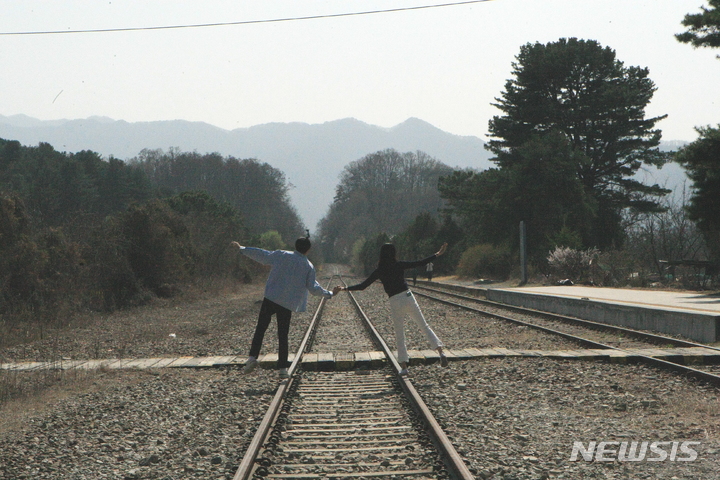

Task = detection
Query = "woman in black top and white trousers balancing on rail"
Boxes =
[340,243,447,375]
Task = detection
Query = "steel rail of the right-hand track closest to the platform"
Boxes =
[415,285,720,351]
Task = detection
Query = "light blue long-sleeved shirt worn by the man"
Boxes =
[240,247,332,312]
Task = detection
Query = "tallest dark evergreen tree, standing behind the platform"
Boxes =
[488,38,668,248]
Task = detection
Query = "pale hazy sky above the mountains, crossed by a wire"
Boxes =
[0,0,720,140]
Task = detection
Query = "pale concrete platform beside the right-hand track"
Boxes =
[483,286,720,343]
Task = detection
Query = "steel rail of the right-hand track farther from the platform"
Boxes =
[416,284,720,386]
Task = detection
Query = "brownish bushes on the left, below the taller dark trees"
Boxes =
[0,188,256,316]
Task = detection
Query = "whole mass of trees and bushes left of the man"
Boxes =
[0,139,303,323]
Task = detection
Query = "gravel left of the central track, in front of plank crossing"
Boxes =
[0,369,278,480]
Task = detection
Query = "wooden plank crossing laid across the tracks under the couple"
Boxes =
[0,347,720,372]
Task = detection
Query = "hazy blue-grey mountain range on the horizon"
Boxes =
[0,115,491,229]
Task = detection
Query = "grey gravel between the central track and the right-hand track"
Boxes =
[346,285,720,480]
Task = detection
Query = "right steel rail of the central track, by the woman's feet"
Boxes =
[343,282,475,480]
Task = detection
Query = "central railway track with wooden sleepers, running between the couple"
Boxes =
[233,278,474,480]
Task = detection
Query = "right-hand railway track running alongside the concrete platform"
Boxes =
[413,285,720,386]
